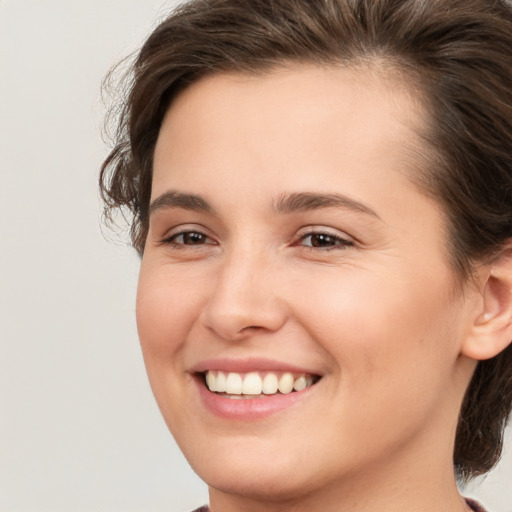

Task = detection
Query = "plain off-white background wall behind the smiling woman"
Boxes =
[0,0,512,512]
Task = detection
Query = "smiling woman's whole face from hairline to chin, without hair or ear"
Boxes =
[137,66,476,497]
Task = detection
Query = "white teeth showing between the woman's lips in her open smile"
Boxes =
[202,370,320,399]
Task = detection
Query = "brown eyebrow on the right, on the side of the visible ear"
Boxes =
[272,192,380,219]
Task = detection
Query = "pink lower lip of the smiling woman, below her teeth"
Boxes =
[194,377,316,421]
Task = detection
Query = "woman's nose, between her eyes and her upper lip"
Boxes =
[202,247,287,341]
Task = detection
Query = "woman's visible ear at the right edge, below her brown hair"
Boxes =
[461,247,512,360]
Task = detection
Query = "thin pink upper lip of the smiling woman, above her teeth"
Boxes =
[190,358,320,375]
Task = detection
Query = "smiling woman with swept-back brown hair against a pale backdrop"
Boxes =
[101,0,512,512]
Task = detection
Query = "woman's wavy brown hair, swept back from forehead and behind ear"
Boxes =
[100,0,512,479]
